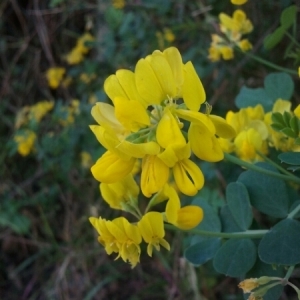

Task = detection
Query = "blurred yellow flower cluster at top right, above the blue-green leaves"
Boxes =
[208,9,253,61]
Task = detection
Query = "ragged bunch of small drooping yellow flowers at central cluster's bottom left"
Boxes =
[89,217,142,268]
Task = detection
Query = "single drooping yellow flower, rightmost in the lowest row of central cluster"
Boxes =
[137,212,170,256]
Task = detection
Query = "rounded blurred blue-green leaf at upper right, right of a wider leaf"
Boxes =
[264,72,294,103]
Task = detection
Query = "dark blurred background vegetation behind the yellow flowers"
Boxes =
[0,0,300,300]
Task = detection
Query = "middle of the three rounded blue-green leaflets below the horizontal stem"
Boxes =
[213,239,256,277]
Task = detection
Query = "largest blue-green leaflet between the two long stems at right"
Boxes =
[238,162,289,218]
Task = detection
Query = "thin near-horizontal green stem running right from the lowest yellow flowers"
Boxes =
[165,224,269,239]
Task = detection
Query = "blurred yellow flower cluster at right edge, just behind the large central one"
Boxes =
[219,99,300,162]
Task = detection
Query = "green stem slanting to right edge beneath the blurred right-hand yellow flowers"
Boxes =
[224,153,300,184]
